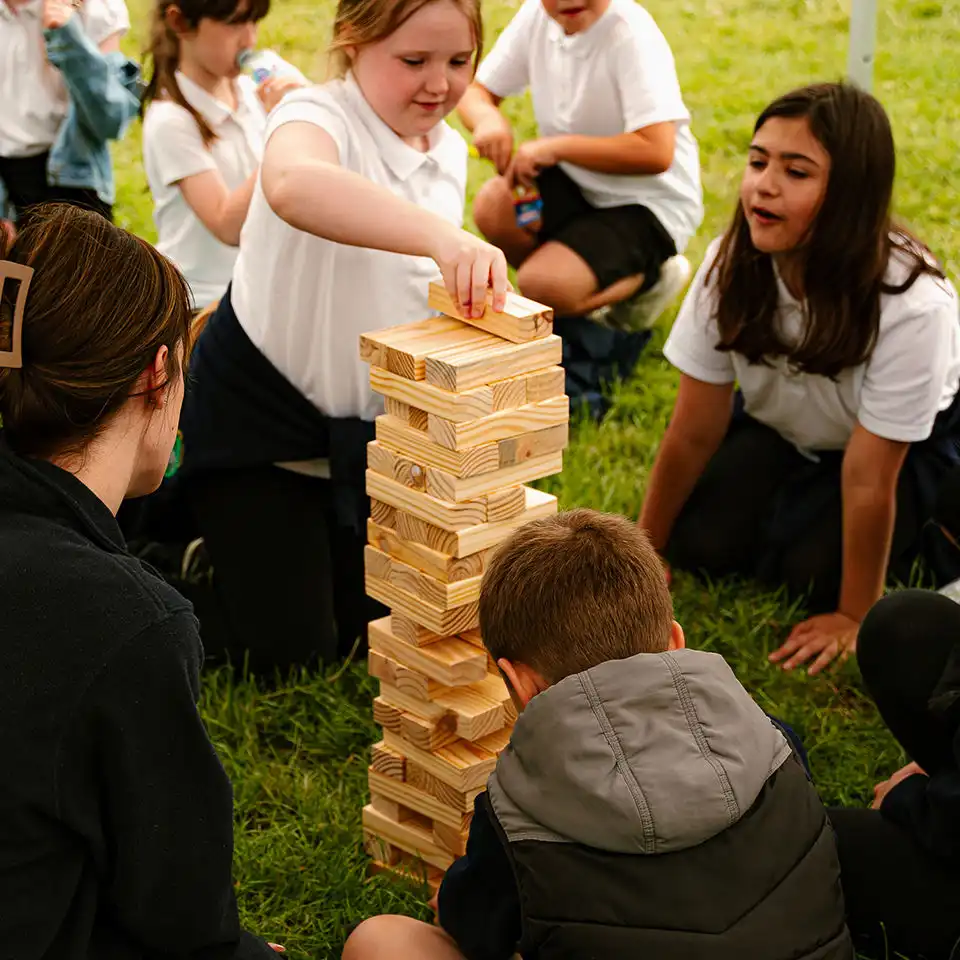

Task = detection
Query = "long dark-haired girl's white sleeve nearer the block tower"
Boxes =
[663,240,737,384]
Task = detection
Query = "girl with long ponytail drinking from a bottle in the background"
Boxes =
[143,0,301,310]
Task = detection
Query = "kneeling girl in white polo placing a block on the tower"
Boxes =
[177,0,507,669]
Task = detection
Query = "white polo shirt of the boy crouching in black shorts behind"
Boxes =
[477,0,703,252]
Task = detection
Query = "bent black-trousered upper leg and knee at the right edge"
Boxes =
[857,590,960,774]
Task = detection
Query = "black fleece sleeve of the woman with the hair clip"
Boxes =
[57,612,277,960]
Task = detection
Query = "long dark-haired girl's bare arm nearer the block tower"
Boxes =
[638,374,734,552]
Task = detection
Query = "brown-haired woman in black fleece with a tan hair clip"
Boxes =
[0,206,282,960]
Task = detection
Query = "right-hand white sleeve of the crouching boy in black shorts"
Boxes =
[613,20,690,133]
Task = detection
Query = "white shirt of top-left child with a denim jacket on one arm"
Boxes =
[0,0,130,157]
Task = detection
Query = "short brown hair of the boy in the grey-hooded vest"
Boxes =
[480,509,673,683]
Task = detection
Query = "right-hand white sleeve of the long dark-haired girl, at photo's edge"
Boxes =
[857,276,960,443]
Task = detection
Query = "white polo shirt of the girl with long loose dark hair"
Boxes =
[663,241,960,453]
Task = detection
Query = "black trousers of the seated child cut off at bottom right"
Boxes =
[830,590,960,960]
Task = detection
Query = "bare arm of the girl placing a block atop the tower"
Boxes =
[261,121,508,316]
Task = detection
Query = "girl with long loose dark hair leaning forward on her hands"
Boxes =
[640,84,960,672]
